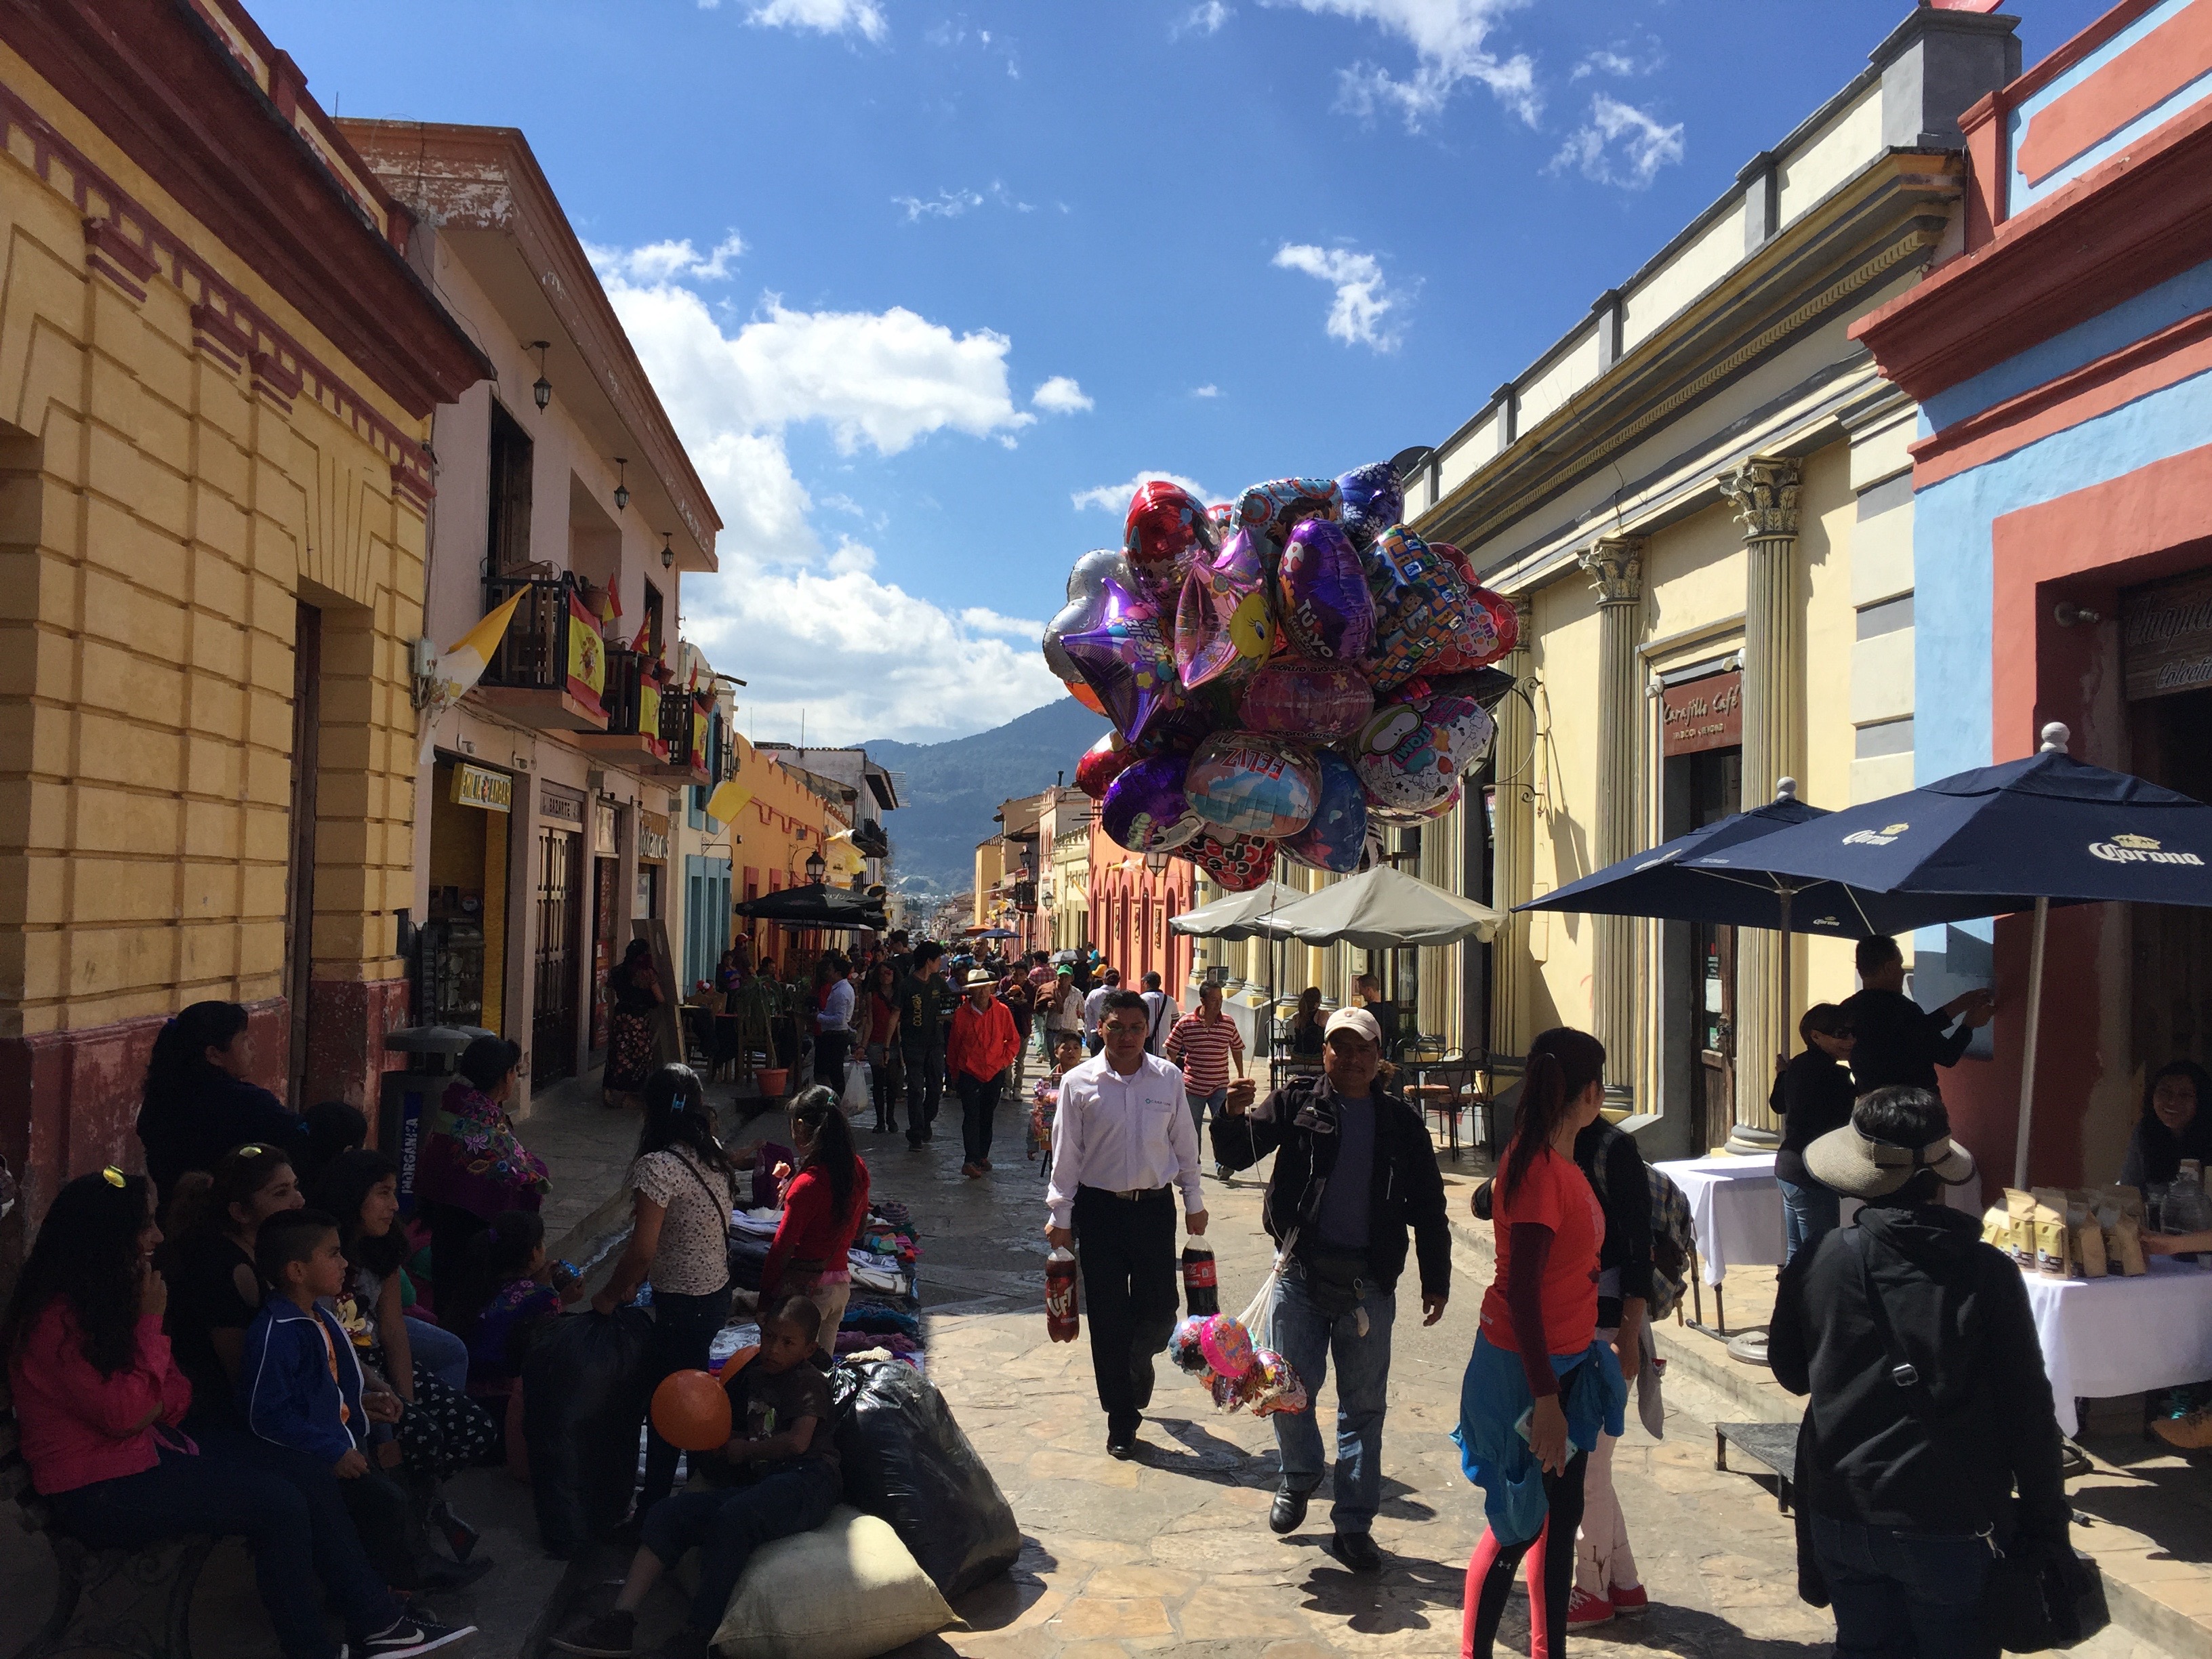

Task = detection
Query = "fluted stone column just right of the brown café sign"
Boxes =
[1721,458,1805,1150]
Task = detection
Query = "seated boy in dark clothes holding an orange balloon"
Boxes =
[553,1296,843,1659]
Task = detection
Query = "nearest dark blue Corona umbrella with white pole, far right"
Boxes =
[1690,726,2212,1186]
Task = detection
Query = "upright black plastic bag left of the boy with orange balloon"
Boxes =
[522,1307,653,1561]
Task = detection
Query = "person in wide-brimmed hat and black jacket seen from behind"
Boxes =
[1767,1088,2072,1659]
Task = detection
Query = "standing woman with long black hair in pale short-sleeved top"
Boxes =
[590,1066,737,1517]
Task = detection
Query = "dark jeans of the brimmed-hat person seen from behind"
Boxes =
[1807,1515,1997,1659]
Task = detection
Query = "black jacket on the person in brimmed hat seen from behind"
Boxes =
[1767,1204,2068,1540]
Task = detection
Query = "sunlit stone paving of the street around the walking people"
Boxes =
[898,1120,2163,1659]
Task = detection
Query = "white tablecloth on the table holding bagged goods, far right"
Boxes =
[2020,1256,2212,1433]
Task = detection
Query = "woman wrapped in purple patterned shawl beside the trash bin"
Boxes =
[413,1038,553,1298]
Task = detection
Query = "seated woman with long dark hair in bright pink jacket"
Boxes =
[0,1166,425,1659]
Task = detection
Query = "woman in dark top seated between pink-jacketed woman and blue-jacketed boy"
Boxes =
[161,1143,305,1435]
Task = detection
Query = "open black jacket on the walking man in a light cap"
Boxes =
[1214,1078,1451,1296]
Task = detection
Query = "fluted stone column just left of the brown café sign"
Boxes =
[1582,535,1643,1084]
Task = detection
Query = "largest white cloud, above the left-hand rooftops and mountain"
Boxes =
[595,239,1064,741]
